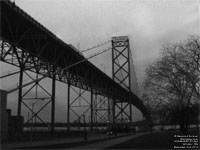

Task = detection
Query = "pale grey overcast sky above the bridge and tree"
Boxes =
[2,0,200,122]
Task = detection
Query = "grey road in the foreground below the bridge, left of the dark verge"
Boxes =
[1,133,146,149]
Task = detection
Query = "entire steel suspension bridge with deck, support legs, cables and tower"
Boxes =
[0,1,151,138]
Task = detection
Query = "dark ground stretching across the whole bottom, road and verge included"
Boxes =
[2,130,199,149]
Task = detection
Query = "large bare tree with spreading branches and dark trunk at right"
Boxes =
[145,36,200,132]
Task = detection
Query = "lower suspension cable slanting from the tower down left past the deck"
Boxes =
[8,47,112,94]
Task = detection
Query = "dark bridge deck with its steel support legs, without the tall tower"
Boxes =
[0,1,149,133]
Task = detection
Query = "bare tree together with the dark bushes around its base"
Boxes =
[142,35,200,133]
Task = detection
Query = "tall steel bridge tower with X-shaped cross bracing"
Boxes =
[112,36,132,123]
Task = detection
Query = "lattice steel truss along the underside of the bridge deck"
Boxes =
[0,39,123,97]
